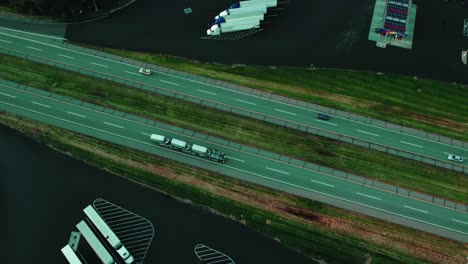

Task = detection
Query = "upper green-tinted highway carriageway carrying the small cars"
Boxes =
[0,26,468,167]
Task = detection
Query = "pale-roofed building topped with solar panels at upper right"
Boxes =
[369,0,416,49]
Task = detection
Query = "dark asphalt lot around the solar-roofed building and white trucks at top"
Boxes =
[66,0,468,83]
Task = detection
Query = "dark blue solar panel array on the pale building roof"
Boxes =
[383,0,410,34]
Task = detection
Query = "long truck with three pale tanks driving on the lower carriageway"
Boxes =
[150,134,226,163]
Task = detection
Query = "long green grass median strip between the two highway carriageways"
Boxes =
[0,55,468,202]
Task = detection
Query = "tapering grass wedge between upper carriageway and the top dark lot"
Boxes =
[93,47,468,141]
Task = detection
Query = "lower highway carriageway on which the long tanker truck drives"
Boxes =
[0,81,468,242]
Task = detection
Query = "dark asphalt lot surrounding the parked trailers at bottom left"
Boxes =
[0,126,310,263]
